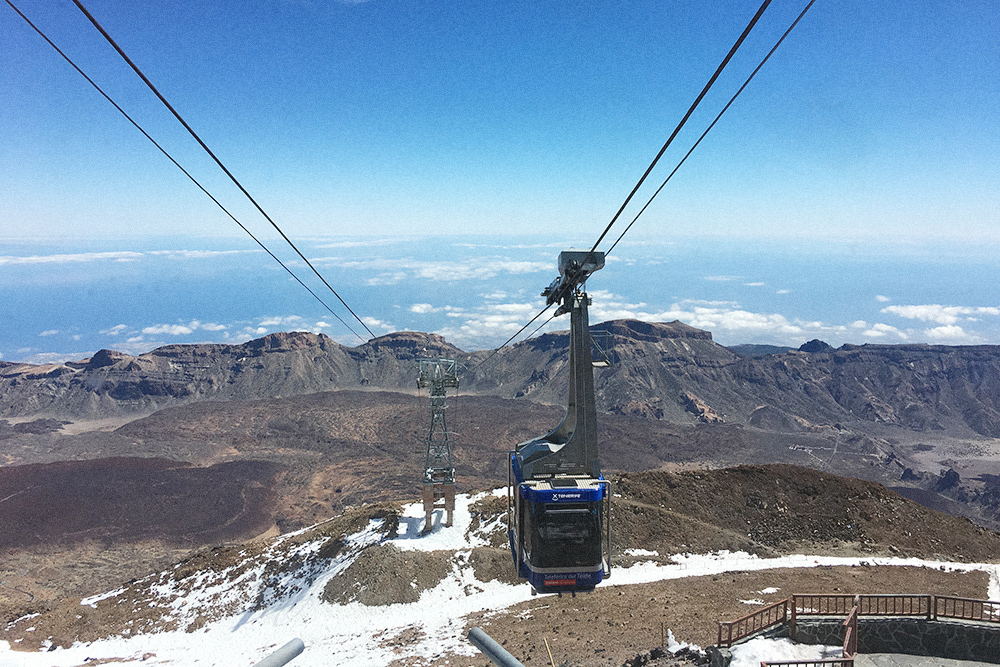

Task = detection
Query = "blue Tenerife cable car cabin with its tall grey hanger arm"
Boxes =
[507,250,611,593]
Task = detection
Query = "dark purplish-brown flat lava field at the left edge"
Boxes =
[0,458,281,551]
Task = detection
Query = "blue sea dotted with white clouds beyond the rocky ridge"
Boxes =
[0,234,1000,364]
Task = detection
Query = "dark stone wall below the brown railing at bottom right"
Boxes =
[795,616,1000,664]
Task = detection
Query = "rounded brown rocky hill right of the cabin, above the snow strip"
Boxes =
[615,464,1000,562]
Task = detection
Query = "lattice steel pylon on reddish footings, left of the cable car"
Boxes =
[417,359,458,533]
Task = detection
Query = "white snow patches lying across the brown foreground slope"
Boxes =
[0,490,1000,667]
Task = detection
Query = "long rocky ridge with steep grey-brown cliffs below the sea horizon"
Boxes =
[7,320,1000,437]
